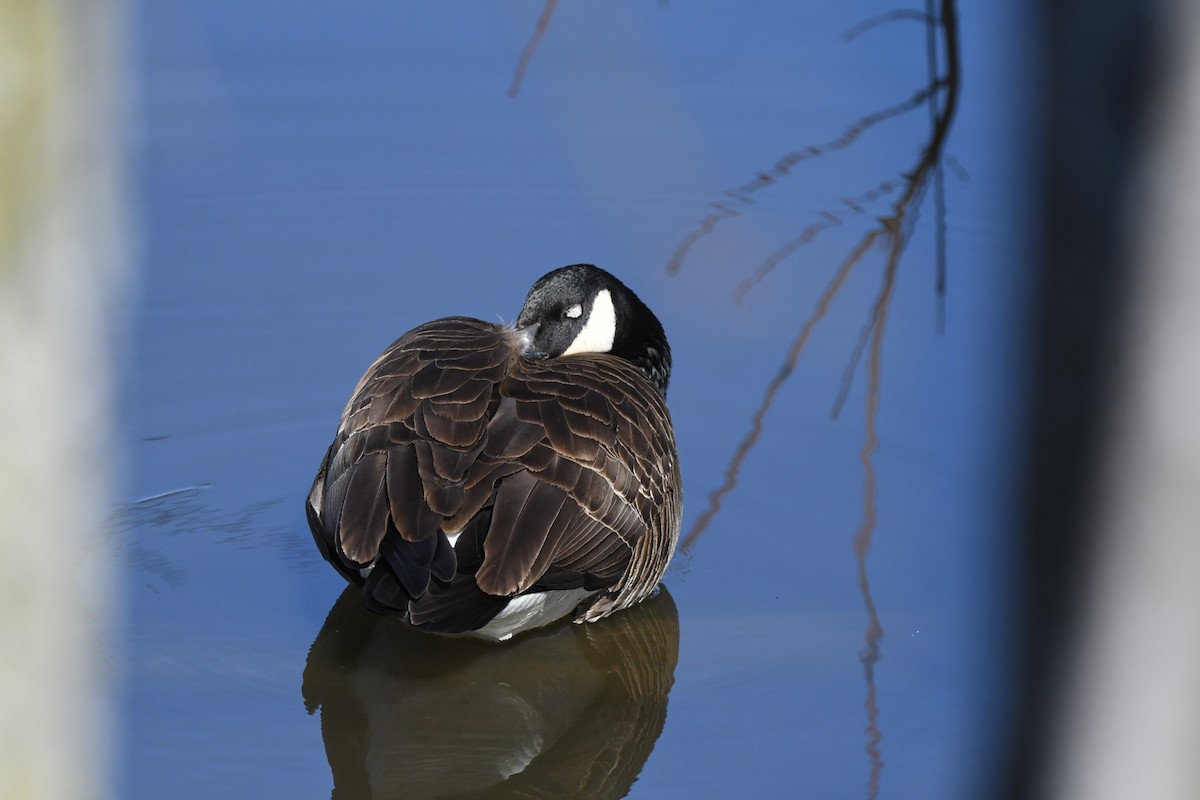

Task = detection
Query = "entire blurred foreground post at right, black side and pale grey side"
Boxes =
[1002,0,1200,799]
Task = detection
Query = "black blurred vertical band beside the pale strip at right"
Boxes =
[1009,0,1150,798]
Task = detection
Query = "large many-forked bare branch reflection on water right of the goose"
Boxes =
[666,0,960,799]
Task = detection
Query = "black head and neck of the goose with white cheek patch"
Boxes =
[516,264,671,397]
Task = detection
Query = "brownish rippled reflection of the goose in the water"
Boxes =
[302,587,679,799]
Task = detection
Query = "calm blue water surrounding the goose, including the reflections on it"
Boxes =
[121,0,1031,799]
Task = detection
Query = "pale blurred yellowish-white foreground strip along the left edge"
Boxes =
[0,0,126,800]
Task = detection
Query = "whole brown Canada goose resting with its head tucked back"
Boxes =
[307,264,683,640]
